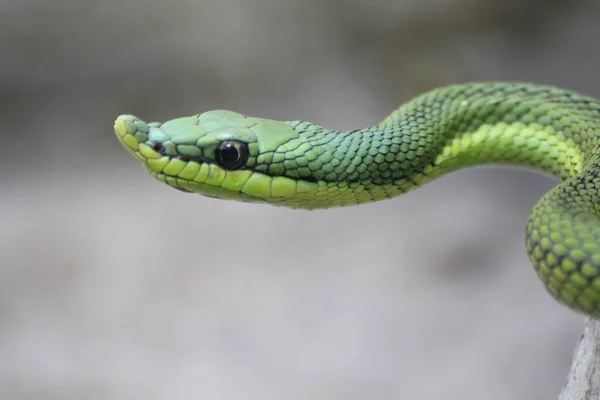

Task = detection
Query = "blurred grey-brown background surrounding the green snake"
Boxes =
[0,0,600,400]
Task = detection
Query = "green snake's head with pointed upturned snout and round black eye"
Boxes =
[114,110,315,203]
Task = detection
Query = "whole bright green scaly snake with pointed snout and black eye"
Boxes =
[114,82,600,317]
